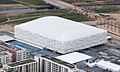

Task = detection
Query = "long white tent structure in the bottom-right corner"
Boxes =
[96,60,120,72]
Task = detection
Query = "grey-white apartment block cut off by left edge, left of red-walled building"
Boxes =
[0,48,12,65]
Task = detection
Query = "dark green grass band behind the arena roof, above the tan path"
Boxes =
[9,10,92,22]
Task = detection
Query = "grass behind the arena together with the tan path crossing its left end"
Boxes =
[2,10,92,25]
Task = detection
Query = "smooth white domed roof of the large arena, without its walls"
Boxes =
[15,16,106,42]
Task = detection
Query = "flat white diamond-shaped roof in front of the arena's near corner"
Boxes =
[56,52,93,64]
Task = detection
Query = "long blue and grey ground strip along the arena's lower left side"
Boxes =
[7,40,61,57]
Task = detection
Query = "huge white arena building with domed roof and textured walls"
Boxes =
[14,16,107,54]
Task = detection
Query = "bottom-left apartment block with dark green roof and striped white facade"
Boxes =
[8,60,38,72]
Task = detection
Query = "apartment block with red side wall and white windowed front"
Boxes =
[0,45,27,62]
